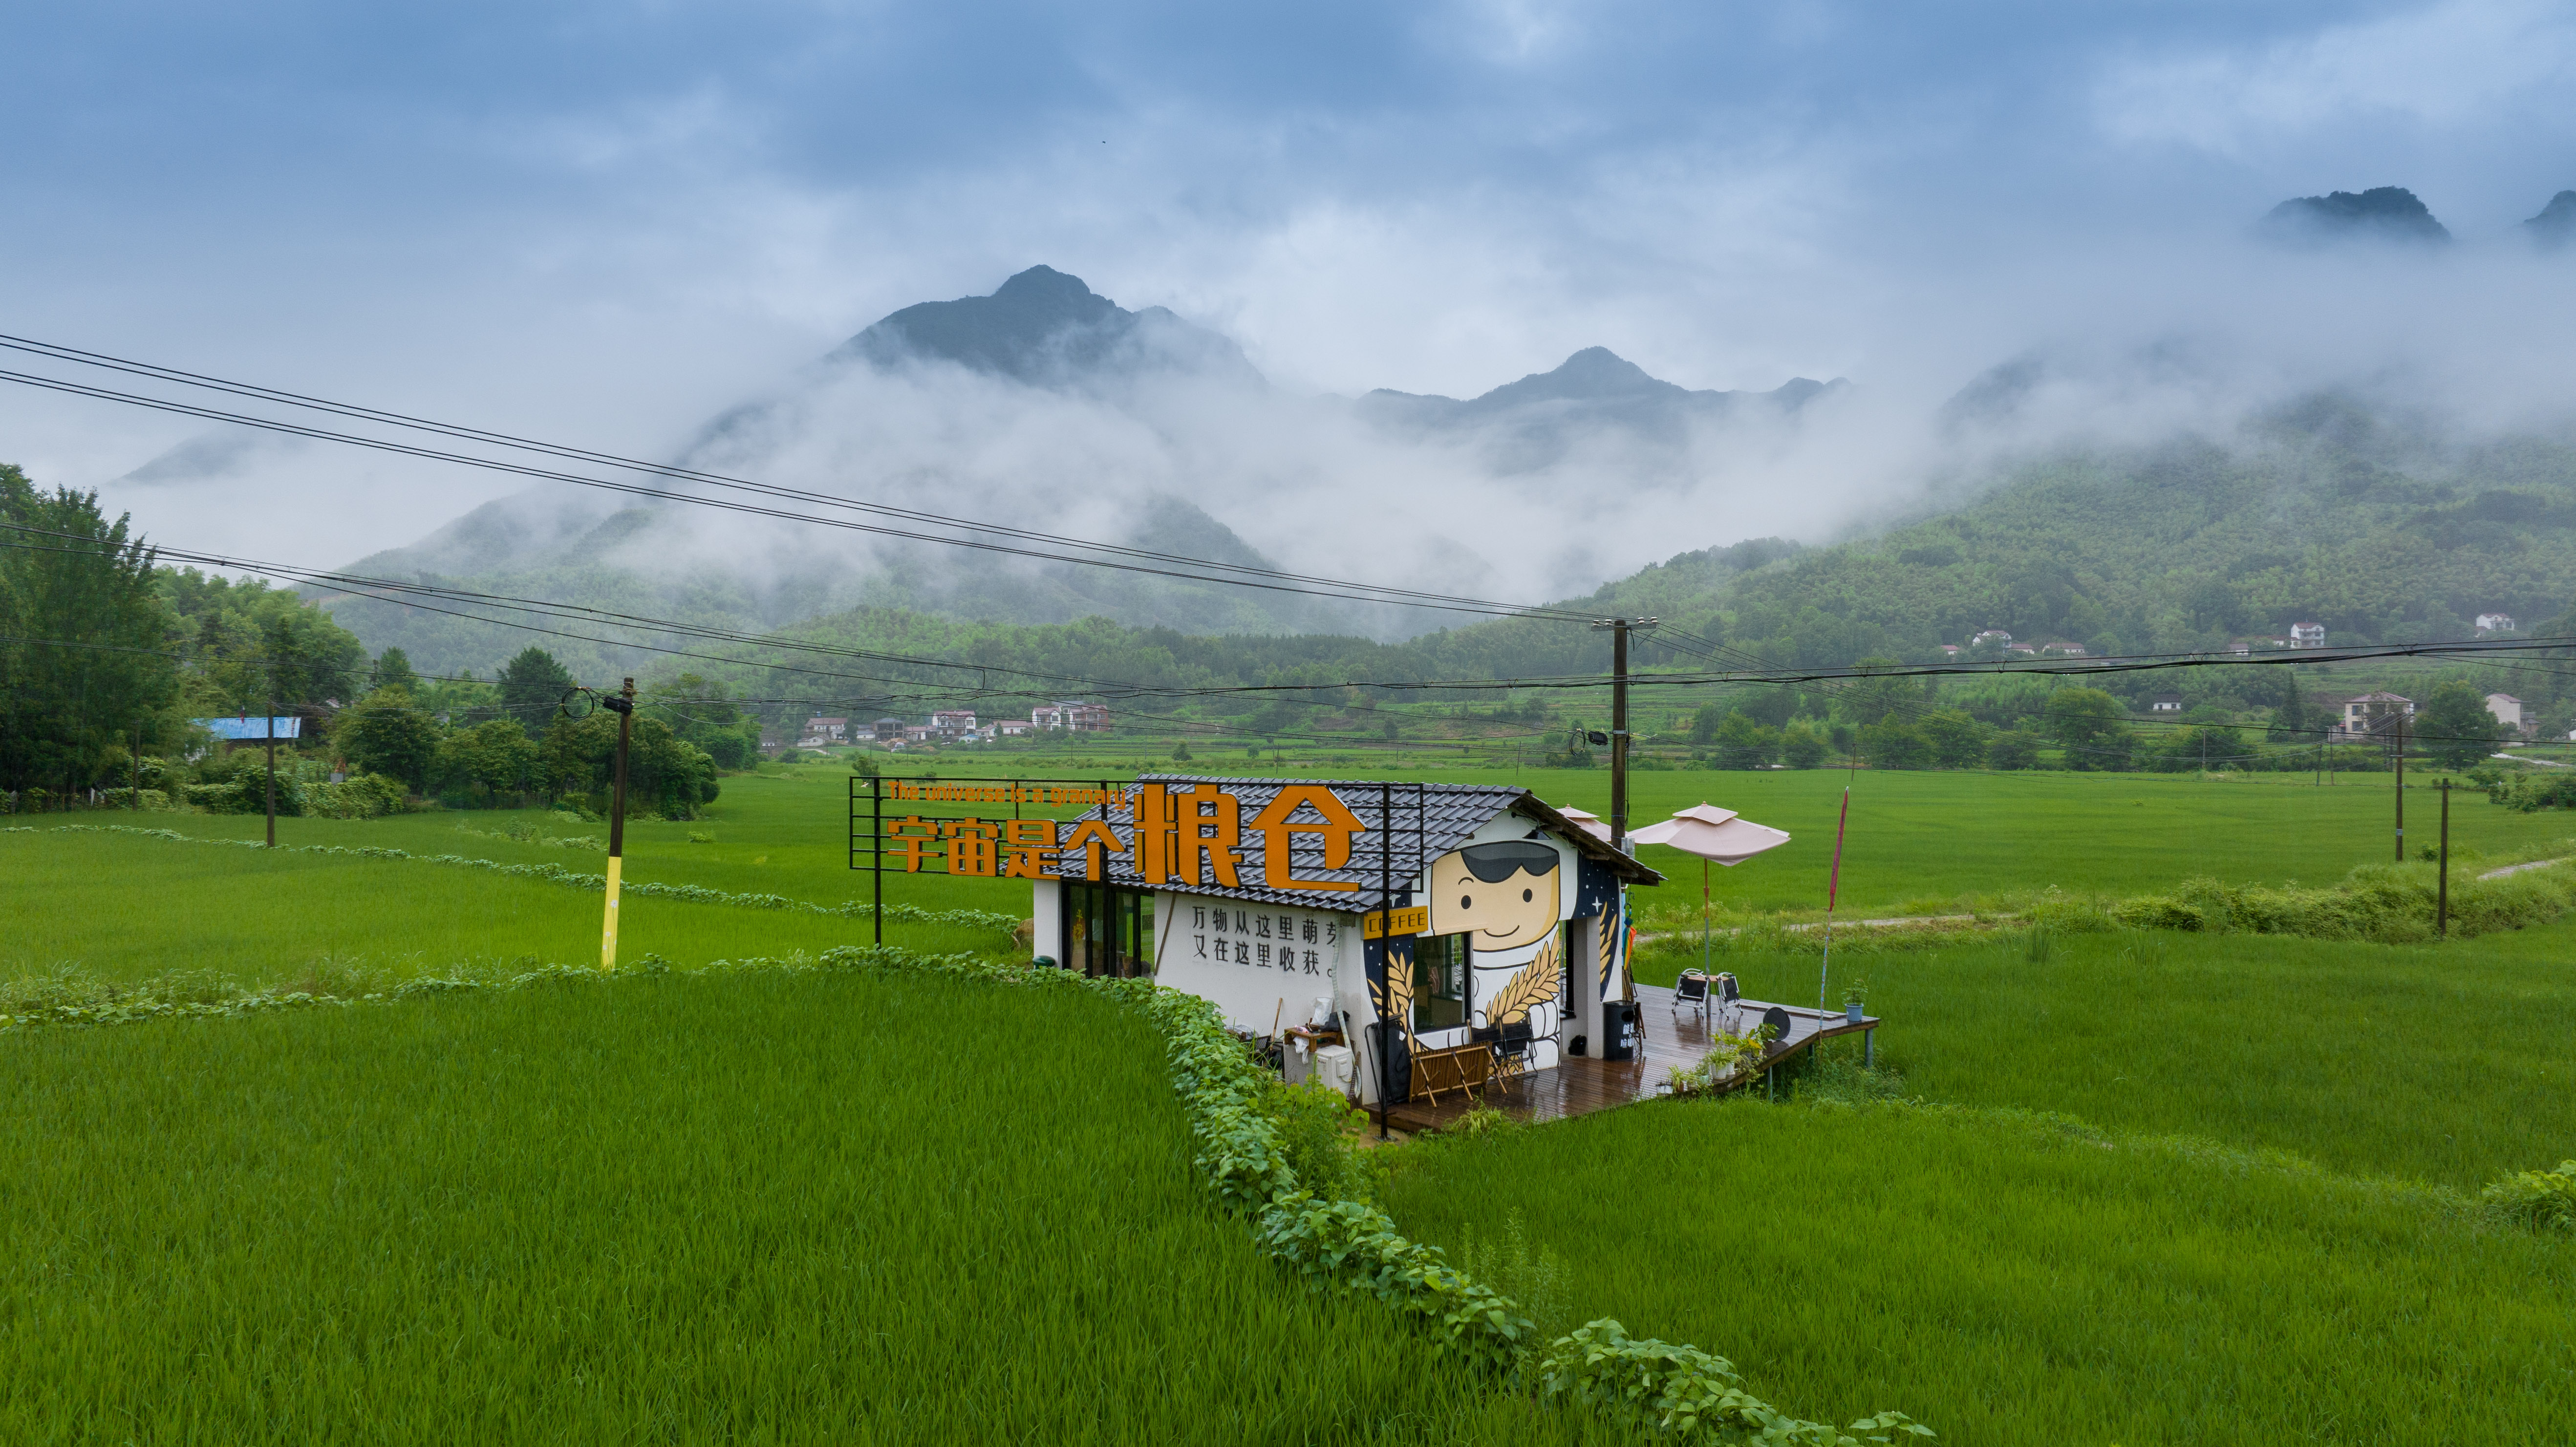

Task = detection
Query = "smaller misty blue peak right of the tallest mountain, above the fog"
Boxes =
[1355,348,1849,474]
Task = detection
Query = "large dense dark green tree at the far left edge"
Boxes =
[0,464,180,790]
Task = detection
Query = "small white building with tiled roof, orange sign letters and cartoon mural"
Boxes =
[1015,775,1661,1105]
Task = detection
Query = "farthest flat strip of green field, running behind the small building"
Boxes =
[70,760,2576,914]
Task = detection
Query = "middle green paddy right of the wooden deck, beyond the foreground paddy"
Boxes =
[1638,924,2576,1190]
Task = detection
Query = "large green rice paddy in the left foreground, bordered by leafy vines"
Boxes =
[0,973,1548,1445]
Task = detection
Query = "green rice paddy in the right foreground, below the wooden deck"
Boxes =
[1391,1097,2576,1447]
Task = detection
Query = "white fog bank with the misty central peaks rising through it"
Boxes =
[150,265,1849,667]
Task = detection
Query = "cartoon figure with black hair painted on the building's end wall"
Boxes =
[1424,837,1574,1071]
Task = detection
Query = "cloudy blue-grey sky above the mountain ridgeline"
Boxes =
[0,0,2576,559]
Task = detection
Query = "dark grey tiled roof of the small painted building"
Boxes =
[1056,775,1664,912]
